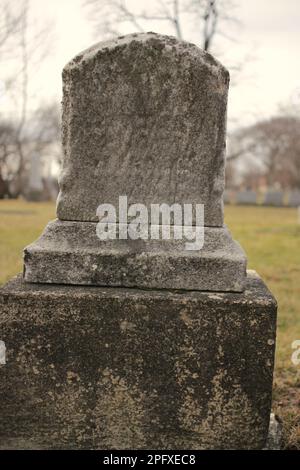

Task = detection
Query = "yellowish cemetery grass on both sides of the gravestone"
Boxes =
[0,200,300,449]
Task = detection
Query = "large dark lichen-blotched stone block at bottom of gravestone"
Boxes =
[0,272,276,449]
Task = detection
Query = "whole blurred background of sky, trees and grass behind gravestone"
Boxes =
[0,0,300,449]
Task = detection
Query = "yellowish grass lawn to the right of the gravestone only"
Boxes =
[225,206,300,449]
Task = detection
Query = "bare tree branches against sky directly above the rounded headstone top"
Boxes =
[85,0,237,51]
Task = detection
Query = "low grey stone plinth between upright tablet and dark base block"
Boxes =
[24,220,246,292]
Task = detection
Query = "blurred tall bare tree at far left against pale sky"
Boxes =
[0,0,51,196]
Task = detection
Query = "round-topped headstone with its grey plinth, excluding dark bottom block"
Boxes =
[25,34,246,292]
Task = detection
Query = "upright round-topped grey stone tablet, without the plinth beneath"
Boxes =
[57,33,229,226]
